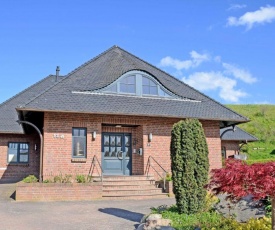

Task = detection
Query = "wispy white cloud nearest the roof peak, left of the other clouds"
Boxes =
[160,50,210,70]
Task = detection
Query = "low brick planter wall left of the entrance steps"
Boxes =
[16,182,102,201]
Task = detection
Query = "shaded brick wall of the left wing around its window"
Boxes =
[0,134,40,182]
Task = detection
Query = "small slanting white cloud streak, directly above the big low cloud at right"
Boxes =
[222,63,257,84]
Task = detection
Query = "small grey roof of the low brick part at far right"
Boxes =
[220,126,258,142]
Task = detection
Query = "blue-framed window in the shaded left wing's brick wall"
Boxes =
[8,142,29,163]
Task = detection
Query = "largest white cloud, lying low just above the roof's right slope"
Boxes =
[182,71,247,102]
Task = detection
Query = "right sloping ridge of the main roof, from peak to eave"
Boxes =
[115,46,249,121]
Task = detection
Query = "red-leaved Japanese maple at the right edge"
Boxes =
[207,159,275,230]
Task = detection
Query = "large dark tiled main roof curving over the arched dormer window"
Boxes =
[18,46,248,127]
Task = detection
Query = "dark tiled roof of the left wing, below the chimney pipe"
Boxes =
[0,75,63,134]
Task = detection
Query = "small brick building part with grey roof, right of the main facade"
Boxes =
[220,126,258,158]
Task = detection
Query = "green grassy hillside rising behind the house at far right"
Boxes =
[227,105,275,163]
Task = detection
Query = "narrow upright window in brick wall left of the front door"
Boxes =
[72,128,87,158]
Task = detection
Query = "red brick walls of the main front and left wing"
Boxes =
[0,112,222,179]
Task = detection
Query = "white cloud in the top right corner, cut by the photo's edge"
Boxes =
[227,6,275,29]
